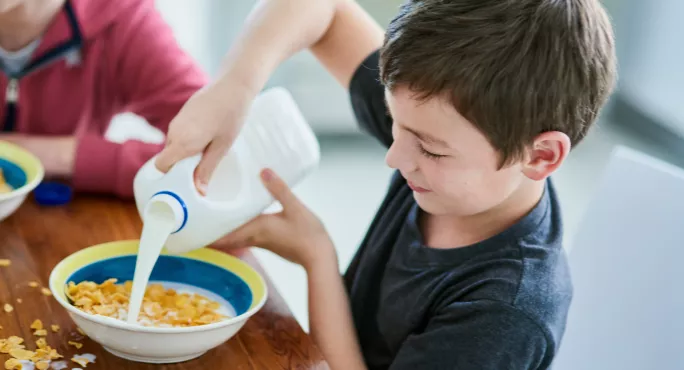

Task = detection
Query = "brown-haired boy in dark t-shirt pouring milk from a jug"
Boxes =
[157,0,615,370]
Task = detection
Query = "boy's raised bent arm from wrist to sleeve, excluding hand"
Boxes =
[216,0,384,99]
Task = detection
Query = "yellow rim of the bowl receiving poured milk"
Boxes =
[49,239,268,334]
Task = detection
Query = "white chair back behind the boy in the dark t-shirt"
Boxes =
[552,147,684,370]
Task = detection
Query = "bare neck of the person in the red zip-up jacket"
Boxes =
[0,0,66,51]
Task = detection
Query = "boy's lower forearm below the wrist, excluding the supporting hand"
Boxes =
[305,245,366,370]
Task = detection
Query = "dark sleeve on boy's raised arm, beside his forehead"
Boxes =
[349,50,392,147]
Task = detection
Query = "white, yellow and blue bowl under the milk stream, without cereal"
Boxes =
[50,240,267,363]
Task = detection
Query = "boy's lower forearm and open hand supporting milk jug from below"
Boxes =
[221,170,365,370]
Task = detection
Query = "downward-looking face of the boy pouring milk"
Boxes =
[385,88,531,216]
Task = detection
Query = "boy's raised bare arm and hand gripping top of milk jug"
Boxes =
[157,0,384,190]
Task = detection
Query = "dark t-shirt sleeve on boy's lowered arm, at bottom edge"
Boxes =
[390,301,553,370]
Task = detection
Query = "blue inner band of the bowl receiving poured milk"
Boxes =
[67,255,252,315]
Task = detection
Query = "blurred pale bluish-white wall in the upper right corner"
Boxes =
[615,0,684,137]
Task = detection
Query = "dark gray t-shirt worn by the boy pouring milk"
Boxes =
[345,52,572,370]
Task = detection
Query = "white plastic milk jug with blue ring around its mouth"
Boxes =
[133,87,320,253]
